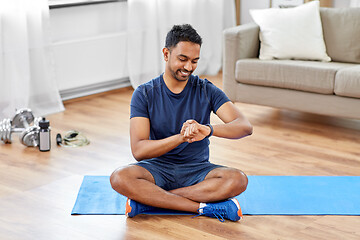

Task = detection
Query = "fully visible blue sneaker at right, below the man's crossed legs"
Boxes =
[198,198,243,222]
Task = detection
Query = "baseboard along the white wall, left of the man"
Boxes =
[60,77,131,101]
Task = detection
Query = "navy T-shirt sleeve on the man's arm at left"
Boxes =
[130,86,149,118]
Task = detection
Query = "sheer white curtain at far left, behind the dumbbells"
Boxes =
[0,0,64,120]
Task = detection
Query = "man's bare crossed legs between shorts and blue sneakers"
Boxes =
[110,165,248,213]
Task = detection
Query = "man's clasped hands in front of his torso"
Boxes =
[180,119,211,143]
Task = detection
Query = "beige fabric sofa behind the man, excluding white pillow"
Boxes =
[223,8,360,119]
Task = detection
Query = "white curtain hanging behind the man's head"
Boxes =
[127,0,236,88]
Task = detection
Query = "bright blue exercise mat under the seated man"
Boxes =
[71,176,360,215]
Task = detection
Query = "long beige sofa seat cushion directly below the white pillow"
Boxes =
[235,59,355,94]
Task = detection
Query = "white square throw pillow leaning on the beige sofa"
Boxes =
[250,1,331,61]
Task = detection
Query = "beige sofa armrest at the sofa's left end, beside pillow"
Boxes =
[223,23,260,101]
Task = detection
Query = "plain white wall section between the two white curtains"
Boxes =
[50,2,128,98]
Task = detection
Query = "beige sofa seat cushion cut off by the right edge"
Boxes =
[334,65,360,98]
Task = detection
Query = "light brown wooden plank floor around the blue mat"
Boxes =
[0,75,360,240]
